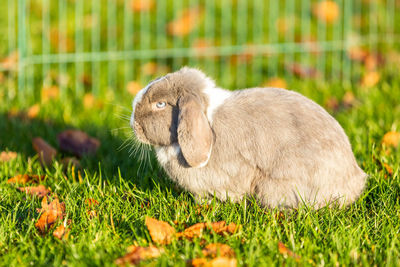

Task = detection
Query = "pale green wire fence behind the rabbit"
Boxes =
[0,0,400,102]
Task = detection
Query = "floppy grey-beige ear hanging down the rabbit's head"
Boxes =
[178,95,213,167]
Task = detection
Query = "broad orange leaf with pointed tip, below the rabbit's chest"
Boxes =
[145,216,176,245]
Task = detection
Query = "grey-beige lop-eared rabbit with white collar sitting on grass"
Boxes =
[130,67,367,209]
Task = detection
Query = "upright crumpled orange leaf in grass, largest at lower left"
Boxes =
[35,196,65,234]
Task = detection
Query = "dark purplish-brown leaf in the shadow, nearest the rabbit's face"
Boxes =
[57,130,100,157]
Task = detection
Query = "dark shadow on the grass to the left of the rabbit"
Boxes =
[0,113,175,195]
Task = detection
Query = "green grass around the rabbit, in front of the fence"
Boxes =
[0,76,400,266]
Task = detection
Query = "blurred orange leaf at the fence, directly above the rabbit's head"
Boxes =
[167,7,203,37]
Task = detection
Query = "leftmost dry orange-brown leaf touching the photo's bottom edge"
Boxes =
[115,246,163,266]
